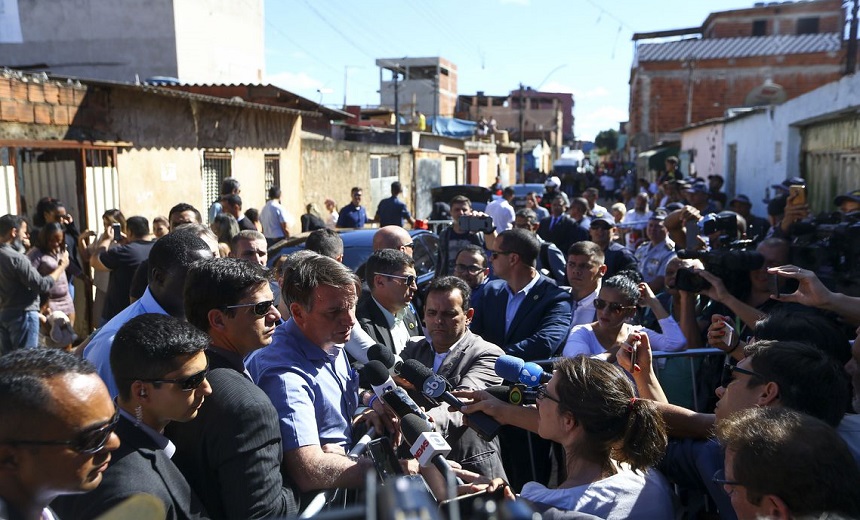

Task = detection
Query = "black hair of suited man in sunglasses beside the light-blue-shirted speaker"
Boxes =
[183,258,270,332]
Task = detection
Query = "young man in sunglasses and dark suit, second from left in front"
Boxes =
[53,314,212,520]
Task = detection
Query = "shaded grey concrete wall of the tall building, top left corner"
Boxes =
[0,0,178,82]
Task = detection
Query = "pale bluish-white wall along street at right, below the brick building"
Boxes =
[724,74,860,209]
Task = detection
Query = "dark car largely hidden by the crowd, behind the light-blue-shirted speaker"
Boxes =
[269,228,439,284]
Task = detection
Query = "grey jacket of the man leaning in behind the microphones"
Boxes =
[400,329,507,479]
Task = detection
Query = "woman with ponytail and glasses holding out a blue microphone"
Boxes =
[455,356,674,520]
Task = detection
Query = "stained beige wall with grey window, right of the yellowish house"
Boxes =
[298,139,414,218]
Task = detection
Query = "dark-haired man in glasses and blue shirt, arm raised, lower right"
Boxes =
[619,341,849,519]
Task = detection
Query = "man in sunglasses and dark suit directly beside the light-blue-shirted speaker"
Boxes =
[166,258,298,518]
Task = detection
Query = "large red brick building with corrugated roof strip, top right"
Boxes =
[630,0,846,151]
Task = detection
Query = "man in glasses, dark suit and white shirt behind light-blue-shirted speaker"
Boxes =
[355,249,423,354]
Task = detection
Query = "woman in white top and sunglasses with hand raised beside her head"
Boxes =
[562,274,687,361]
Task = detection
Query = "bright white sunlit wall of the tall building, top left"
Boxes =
[173,0,265,84]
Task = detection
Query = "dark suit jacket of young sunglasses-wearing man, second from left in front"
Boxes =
[51,416,209,520]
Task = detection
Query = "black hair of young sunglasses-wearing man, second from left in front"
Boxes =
[110,310,209,399]
